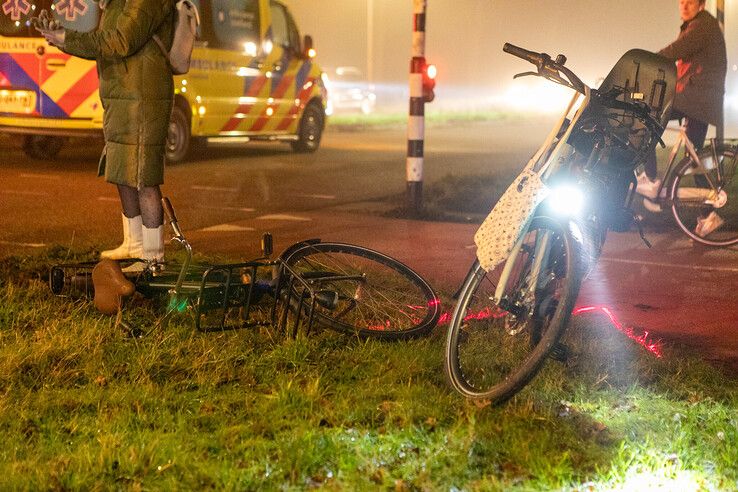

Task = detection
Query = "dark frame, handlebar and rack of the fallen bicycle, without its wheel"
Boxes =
[49,198,355,336]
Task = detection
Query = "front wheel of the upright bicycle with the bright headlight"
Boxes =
[445,217,579,403]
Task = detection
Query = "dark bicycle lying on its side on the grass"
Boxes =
[49,198,440,340]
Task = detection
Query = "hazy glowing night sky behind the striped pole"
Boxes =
[283,0,738,98]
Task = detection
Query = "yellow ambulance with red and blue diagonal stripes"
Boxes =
[0,0,327,162]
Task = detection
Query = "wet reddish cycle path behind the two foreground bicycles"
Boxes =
[180,201,738,366]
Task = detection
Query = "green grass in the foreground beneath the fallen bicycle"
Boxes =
[0,251,738,490]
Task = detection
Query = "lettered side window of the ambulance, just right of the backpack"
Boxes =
[211,0,259,51]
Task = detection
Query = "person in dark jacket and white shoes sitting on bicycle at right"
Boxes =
[636,0,727,236]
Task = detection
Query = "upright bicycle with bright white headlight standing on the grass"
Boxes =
[445,44,680,403]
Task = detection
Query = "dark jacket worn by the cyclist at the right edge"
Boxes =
[659,10,727,125]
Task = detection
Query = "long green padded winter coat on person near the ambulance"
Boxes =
[62,0,174,189]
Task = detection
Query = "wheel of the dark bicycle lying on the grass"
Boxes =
[284,243,440,340]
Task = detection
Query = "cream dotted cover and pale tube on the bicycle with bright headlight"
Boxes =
[474,91,589,272]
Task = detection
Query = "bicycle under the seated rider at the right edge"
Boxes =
[632,121,738,246]
